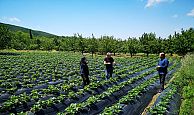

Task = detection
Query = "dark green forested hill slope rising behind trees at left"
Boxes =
[0,22,56,37]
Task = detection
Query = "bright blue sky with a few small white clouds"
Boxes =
[0,0,194,39]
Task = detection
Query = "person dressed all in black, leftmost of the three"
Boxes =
[80,57,90,86]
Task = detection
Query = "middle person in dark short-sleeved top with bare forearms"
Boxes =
[104,52,115,79]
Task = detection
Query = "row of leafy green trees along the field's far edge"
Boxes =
[0,25,194,56]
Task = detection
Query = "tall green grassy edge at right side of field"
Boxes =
[173,53,194,115]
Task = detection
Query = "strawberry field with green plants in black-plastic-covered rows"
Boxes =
[0,52,180,115]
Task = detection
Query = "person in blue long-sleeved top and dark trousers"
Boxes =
[157,53,169,92]
